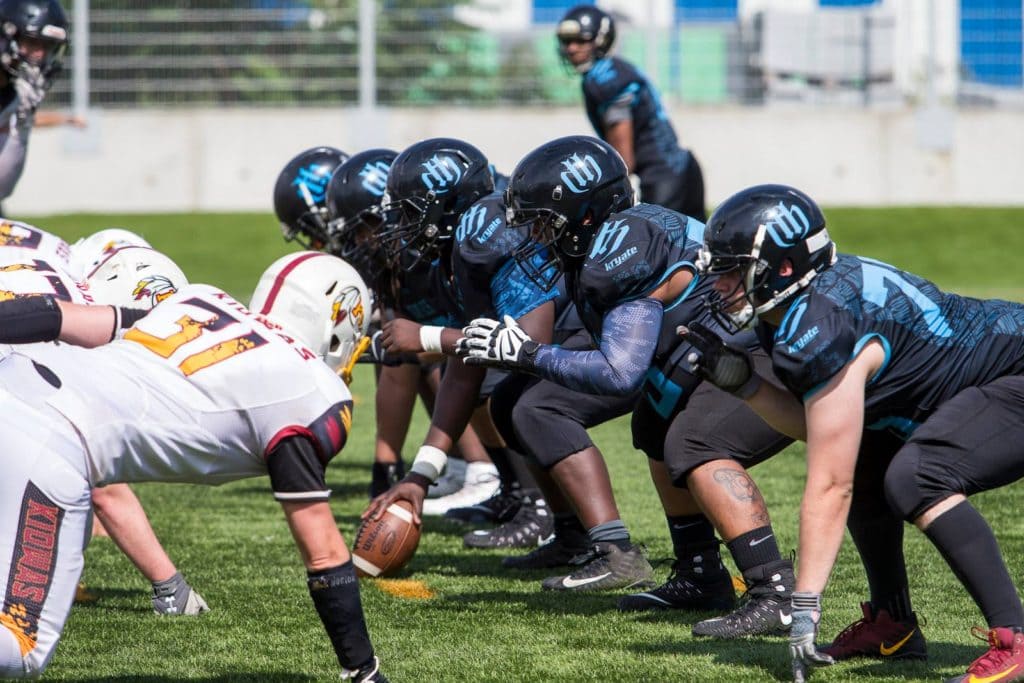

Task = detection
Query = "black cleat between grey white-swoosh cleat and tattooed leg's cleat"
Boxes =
[618,560,736,611]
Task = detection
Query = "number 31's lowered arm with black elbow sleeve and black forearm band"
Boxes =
[266,435,374,671]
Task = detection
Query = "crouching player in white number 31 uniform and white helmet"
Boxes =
[0,252,385,682]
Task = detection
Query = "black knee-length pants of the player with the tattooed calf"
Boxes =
[633,350,793,487]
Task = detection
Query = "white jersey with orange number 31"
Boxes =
[8,285,352,485]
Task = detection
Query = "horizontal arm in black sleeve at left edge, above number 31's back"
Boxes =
[0,295,145,346]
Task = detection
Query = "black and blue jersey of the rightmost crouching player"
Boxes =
[759,254,1024,438]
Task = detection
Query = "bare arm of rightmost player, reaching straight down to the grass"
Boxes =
[797,342,884,593]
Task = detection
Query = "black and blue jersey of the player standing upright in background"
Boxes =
[583,57,690,178]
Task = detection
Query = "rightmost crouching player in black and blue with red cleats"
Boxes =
[689,185,1024,682]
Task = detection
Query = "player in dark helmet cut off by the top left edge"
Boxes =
[0,0,85,215]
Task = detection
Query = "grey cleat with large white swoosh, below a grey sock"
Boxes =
[541,542,654,591]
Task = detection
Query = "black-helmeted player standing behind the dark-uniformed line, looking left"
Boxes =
[557,5,708,221]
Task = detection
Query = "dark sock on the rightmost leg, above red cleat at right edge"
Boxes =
[925,501,1024,629]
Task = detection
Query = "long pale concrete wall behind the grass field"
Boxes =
[12,106,1024,215]
